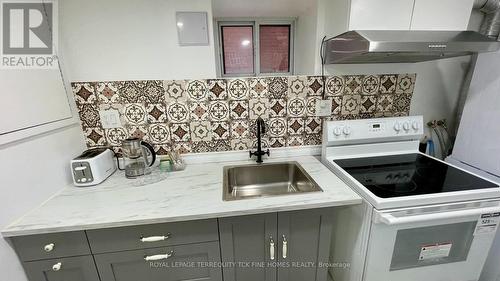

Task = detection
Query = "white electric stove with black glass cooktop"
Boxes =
[322,116,500,281]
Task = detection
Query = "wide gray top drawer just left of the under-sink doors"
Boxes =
[87,219,219,253]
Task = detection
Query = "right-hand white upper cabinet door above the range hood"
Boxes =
[410,0,474,30]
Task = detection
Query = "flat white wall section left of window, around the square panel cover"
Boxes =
[59,0,215,81]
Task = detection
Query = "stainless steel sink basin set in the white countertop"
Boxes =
[223,161,323,201]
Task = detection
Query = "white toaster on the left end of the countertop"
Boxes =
[70,148,116,186]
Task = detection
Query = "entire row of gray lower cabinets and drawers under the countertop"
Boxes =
[12,208,333,281]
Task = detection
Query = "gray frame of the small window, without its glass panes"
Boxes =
[214,18,297,78]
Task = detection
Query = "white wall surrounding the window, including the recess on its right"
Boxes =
[59,0,319,81]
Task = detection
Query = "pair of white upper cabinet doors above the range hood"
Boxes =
[346,0,474,30]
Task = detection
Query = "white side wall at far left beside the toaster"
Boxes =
[0,124,85,281]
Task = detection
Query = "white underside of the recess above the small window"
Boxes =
[212,0,317,18]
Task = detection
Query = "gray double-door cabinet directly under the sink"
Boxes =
[219,208,332,281]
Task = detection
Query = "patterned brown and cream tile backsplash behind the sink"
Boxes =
[72,74,416,154]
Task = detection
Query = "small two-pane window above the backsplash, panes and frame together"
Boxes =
[216,20,294,76]
